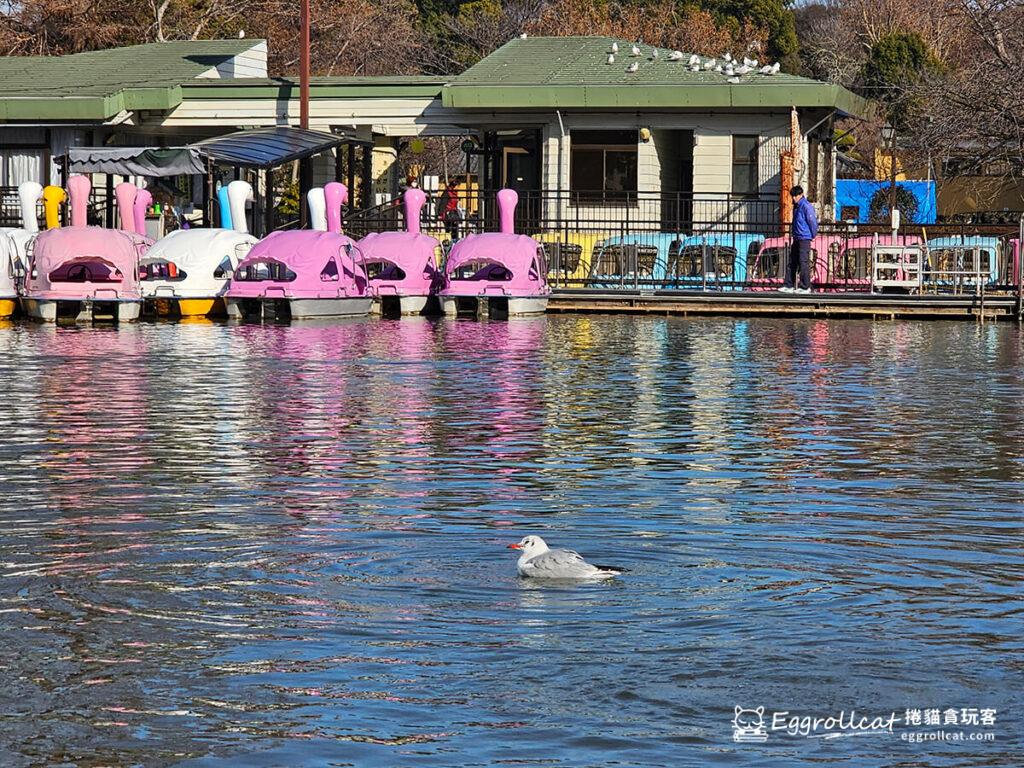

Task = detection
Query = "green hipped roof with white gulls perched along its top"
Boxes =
[442,37,871,117]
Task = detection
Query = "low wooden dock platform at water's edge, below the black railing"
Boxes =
[548,288,1018,321]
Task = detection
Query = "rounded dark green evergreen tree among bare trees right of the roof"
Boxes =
[861,32,942,128]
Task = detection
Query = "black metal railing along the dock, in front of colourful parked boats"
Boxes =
[346,190,1018,293]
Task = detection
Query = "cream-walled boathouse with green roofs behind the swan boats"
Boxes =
[0,37,870,229]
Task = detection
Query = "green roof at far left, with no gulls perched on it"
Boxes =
[0,40,262,121]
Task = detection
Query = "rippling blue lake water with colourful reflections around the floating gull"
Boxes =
[0,316,1024,768]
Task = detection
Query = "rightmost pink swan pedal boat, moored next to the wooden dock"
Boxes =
[438,189,551,317]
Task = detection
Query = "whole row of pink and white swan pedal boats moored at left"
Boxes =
[0,175,550,322]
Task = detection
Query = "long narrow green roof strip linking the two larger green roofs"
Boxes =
[181,75,447,100]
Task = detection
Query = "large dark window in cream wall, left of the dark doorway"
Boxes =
[569,131,637,203]
